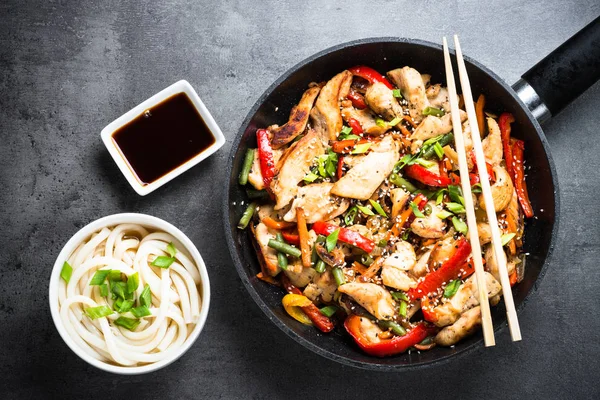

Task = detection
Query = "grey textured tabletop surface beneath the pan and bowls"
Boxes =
[0,0,600,399]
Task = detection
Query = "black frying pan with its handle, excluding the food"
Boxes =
[223,18,600,370]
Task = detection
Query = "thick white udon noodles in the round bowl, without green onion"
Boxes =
[58,224,202,366]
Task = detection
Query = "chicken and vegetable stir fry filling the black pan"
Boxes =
[238,66,533,357]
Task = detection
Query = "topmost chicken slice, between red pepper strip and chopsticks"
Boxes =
[387,67,429,123]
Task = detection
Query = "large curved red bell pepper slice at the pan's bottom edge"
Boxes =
[344,314,438,357]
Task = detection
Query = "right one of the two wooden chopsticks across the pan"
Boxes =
[454,35,521,342]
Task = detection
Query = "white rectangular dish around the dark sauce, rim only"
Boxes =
[100,80,225,196]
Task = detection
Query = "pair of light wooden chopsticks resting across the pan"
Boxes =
[443,35,521,347]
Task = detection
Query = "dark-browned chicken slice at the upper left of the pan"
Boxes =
[269,86,321,149]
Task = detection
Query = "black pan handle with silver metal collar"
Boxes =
[513,17,600,122]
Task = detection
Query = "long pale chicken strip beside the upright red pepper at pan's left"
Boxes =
[271,130,325,210]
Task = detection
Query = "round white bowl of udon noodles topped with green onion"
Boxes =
[50,214,209,373]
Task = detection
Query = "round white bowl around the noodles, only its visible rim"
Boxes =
[50,213,210,375]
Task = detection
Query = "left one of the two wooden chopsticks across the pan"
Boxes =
[442,37,496,347]
